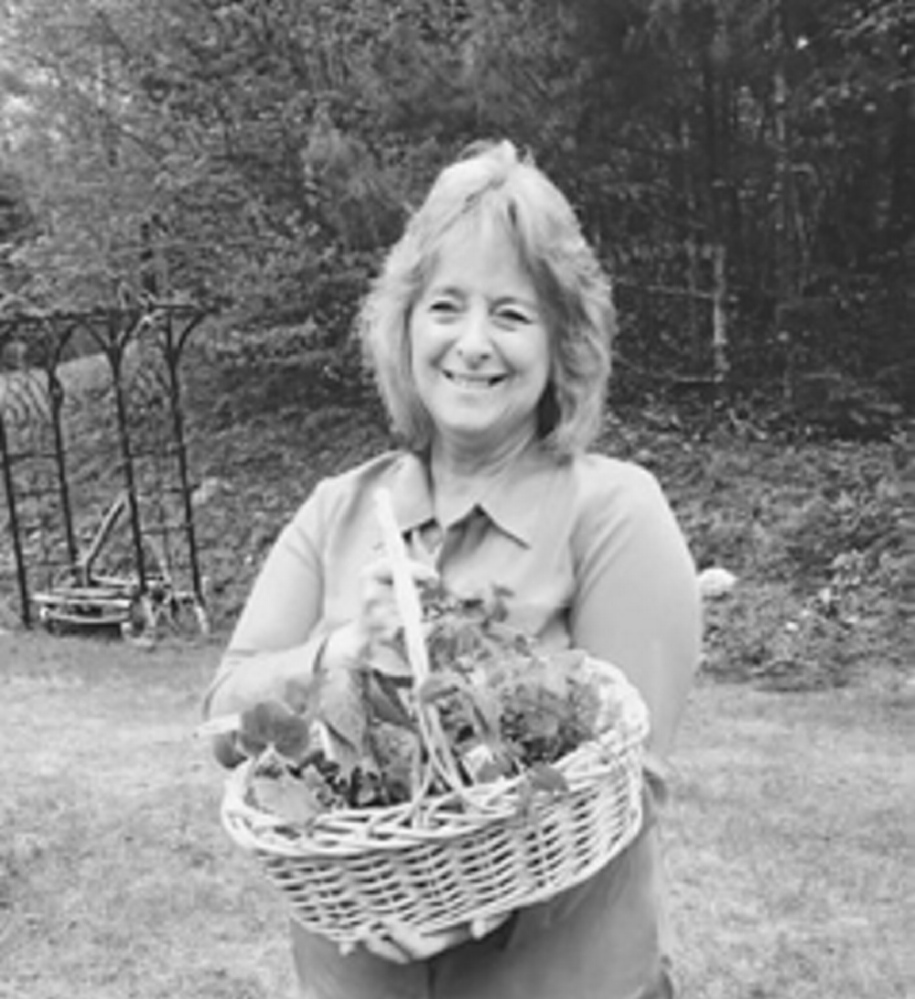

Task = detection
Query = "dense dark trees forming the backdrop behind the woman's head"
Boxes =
[0,0,915,426]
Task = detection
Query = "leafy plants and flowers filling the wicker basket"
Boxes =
[233,585,620,822]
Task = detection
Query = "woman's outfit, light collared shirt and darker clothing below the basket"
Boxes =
[208,446,700,999]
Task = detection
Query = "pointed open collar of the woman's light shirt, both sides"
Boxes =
[391,444,559,547]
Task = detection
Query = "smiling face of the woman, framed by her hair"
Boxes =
[409,220,550,455]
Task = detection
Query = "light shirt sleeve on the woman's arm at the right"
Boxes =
[570,462,701,759]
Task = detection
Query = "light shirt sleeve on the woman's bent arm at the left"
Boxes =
[204,485,326,762]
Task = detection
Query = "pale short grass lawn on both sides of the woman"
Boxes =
[0,632,915,999]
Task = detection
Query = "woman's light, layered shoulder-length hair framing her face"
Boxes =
[359,141,616,455]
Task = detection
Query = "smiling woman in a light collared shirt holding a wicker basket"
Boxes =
[207,142,700,999]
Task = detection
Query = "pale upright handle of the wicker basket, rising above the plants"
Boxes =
[375,488,464,791]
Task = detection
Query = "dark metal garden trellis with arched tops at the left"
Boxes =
[0,301,207,627]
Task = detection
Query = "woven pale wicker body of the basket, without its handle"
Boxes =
[222,668,648,945]
